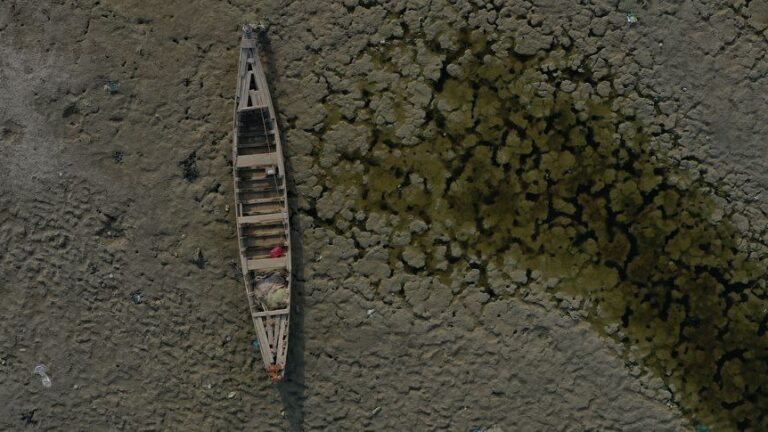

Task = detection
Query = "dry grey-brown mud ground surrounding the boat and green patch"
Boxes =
[0,0,768,431]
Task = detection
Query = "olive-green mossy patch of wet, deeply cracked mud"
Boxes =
[319,32,768,430]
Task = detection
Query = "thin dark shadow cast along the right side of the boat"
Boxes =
[258,32,306,431]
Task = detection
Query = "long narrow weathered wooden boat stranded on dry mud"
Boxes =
[232,26,291,381]
